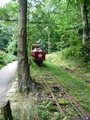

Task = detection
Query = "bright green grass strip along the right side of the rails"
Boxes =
[30,59,90,112]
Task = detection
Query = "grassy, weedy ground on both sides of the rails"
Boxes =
[0,55,90,120]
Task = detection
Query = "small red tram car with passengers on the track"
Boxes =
[31,44,46,65]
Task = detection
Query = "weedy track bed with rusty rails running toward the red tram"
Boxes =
[31,67,89,120]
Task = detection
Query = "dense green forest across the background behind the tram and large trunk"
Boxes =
[0,0,90,67]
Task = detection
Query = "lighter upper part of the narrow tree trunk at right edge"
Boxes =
[81,1,89,48]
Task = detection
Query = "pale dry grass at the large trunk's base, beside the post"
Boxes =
[12,93,39,120]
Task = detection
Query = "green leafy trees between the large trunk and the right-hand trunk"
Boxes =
[28,0,89,62]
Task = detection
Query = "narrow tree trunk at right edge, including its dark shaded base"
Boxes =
[80,0,90,63]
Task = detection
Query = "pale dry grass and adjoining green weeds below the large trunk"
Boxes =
[12,85,62,120]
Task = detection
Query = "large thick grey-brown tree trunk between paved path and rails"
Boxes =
[18,0,32,92]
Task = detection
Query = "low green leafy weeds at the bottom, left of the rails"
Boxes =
[37,100,62,120]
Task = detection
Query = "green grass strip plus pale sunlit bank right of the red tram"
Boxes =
[45,53,90,113]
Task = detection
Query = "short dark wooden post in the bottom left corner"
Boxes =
[1,101,13,120]
